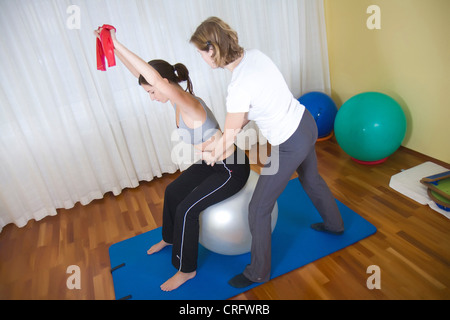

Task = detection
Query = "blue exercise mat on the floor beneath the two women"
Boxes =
[109,179,376,300]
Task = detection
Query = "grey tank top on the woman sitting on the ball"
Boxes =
[177,97,220,145]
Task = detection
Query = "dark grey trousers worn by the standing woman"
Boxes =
[244,110,344,282]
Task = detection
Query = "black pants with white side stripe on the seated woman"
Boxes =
[162,148,250,272]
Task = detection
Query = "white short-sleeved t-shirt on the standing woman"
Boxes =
[227,49,305,146]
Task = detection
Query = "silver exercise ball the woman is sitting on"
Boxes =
[199,171,278,255]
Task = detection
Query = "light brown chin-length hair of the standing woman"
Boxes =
[190,17,244,68]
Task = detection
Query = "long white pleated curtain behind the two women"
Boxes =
[0,0,330,230]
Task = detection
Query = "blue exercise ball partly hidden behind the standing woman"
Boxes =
[298,91,337,138]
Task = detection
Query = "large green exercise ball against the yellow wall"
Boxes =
[334,92,406,164]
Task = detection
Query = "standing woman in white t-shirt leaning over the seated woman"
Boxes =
[190,17,344,288]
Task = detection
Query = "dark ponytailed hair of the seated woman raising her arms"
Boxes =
[138,60,194,94]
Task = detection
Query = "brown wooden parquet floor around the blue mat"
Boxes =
[0,139,450,299]
